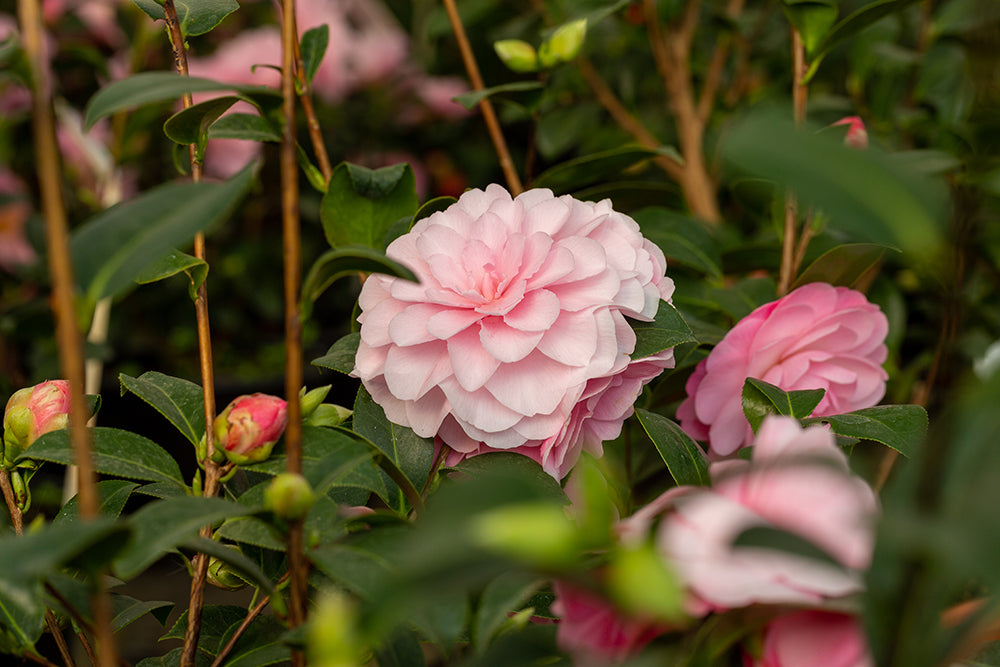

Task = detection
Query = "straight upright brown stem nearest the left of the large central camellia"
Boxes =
[281,0,307,666]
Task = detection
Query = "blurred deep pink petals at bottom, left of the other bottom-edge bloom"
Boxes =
[551,580,669,667]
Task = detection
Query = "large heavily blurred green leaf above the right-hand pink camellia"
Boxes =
[721,112,947,266]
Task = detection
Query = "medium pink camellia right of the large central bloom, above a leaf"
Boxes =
[677,283,889,458]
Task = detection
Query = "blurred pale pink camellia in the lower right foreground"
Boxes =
[656,415,878,611]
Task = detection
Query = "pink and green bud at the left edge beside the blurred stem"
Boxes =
[3,380,69,468]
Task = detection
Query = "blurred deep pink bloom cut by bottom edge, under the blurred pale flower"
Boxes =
[749,610,875,667]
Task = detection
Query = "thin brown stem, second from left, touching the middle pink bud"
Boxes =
[163,0,219,667]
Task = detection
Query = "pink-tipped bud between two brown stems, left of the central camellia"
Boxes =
[213,393,288,464]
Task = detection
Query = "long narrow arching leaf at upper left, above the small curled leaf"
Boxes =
[84,72,281,129]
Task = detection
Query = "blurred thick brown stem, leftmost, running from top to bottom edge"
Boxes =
[18,0,118,667]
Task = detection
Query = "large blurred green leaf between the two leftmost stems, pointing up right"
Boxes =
[70,166,255,313]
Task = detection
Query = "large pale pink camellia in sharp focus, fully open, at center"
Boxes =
[354,185,673,478]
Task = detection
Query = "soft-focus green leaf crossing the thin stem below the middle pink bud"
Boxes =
[114,496,249,579]
